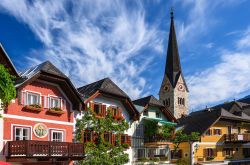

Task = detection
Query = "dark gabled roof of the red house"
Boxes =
[15,61,84,110]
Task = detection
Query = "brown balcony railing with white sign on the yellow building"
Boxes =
[224,133,250,143]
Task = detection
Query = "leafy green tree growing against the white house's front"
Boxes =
[76,109,129,165]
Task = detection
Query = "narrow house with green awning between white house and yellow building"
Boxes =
[132,95,176,163]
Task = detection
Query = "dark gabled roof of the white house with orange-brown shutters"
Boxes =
[78,78,139,120]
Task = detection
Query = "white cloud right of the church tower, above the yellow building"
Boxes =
[187,28,250,108]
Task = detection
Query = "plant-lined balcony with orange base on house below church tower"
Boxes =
[144,135,171,146]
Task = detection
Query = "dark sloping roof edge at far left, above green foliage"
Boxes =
[0,43,19,77]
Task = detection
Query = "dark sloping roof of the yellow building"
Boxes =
[178,107,250,135]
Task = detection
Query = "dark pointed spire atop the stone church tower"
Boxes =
[165,8,182,87]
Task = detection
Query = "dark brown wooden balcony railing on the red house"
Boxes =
[8,140,84,160]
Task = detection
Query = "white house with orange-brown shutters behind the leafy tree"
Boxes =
[76,78,139,164]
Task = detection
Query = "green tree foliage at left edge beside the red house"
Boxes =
[0,64,16,116]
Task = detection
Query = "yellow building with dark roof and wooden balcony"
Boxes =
[172,99,250,164]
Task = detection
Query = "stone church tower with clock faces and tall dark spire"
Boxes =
[159,10,188,119]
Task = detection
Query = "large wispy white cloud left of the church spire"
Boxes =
[0,0,163,98]
